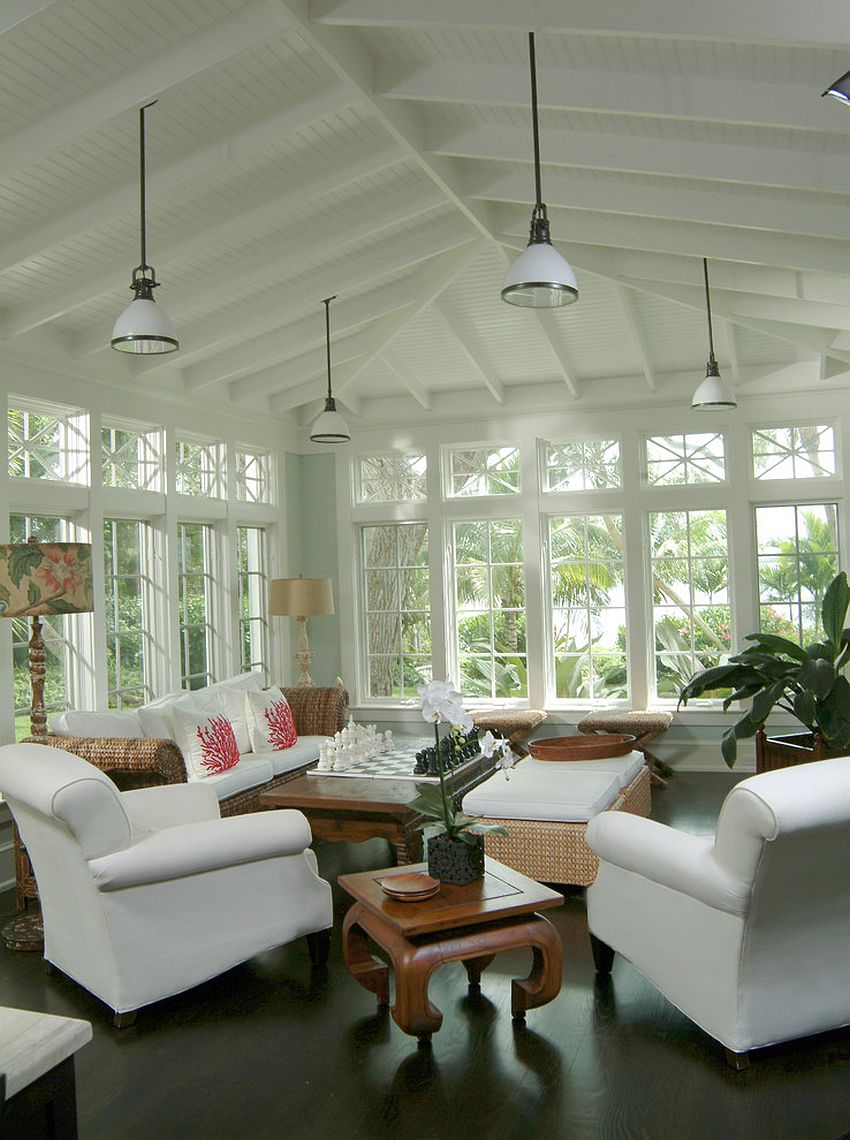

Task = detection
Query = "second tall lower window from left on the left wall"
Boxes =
[104,519,153,709]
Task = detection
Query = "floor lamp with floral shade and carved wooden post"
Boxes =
[0,536,95,950]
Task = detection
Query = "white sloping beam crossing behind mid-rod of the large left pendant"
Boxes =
[0,83,357,272]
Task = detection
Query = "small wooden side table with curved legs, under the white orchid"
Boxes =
[338,858,564,1041]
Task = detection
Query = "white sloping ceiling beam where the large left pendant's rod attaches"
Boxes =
[0,0,291,179]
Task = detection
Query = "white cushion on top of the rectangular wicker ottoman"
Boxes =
[463,762,620,823]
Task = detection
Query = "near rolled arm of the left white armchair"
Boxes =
[89,809,312,890]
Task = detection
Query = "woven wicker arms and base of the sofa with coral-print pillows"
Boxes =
[40,685,349,815]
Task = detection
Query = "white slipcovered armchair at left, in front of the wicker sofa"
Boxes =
[0,744,333,1025]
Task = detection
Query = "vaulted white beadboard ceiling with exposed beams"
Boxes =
[0,0,850,426]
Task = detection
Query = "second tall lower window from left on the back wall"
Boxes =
[452,519,529,698]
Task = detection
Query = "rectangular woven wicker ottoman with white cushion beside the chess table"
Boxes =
[463,752,651,887]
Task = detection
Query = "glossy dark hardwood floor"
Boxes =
[0,773,850,1140]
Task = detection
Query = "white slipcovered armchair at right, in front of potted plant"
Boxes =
[587,758,850,1068]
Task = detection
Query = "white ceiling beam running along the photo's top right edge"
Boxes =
[308,0,850,48]
